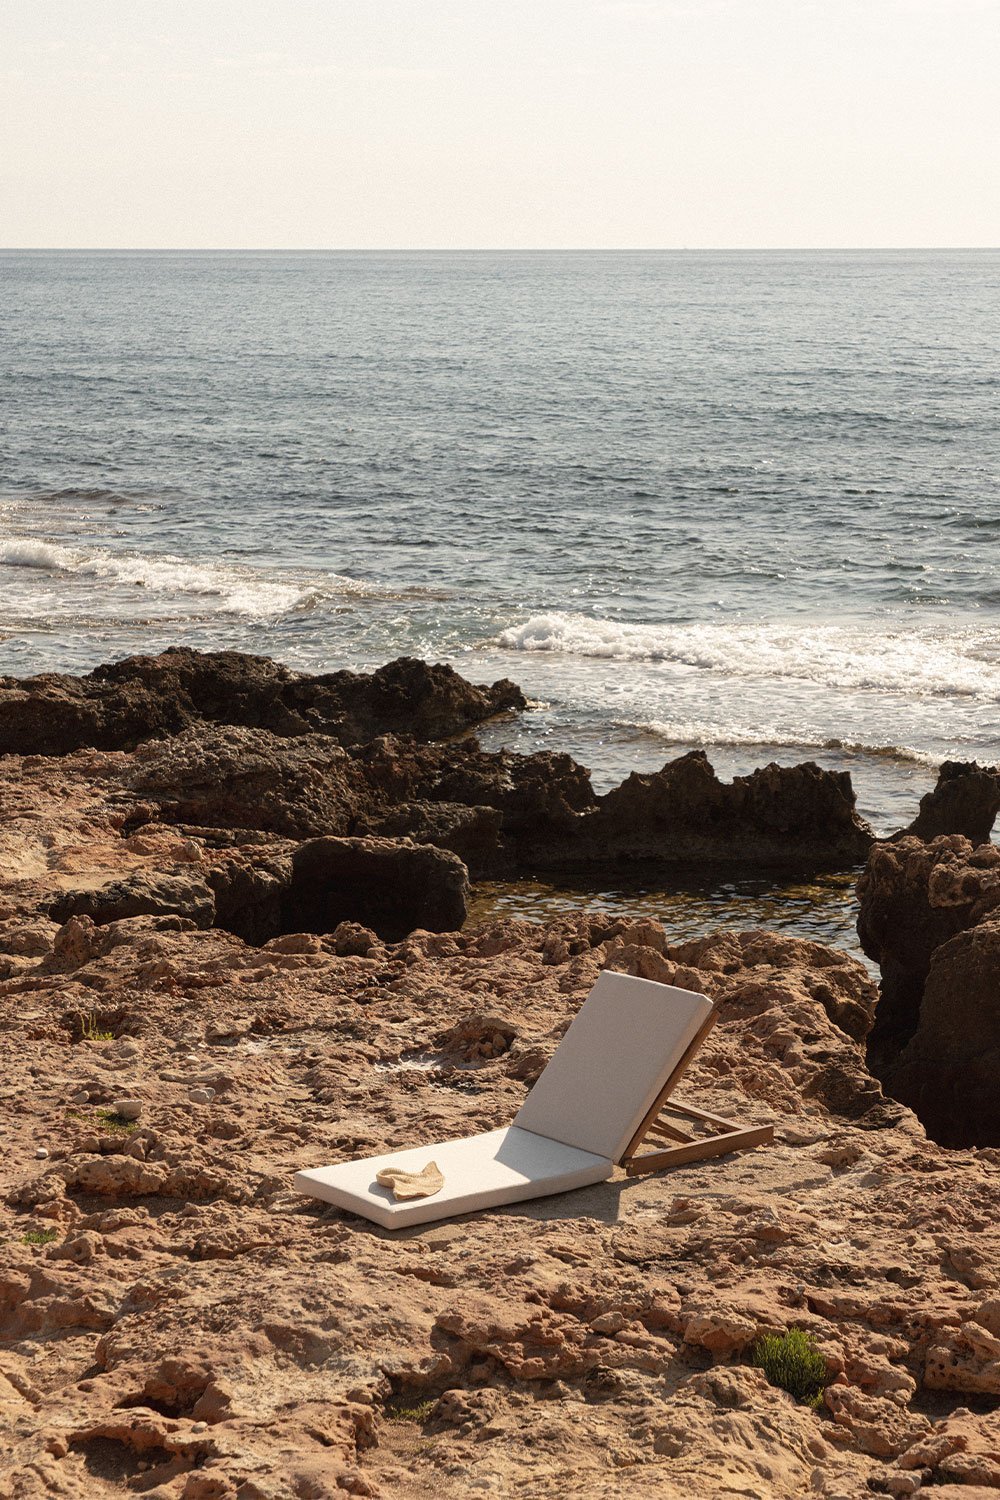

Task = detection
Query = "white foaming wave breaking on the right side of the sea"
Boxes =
[489,611,1000,701]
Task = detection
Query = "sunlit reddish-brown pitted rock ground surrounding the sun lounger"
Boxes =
[0,900,1000,1500]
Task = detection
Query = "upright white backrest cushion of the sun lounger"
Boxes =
[514,969,712,1161]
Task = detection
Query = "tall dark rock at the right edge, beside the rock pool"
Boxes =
[858,834,1000,1145]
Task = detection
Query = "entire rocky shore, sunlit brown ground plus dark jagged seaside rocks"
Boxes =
[0,651,1000,1500]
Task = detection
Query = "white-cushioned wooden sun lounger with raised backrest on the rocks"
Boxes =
[295,971,774,1229]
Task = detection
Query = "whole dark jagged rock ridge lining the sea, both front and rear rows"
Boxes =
[0,651,874,879]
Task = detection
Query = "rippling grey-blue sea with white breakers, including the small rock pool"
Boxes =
[0,251,1000,944]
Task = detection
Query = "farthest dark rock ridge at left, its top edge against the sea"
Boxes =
[0,647,525,755]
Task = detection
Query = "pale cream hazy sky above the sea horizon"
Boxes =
[0,0,1000,249]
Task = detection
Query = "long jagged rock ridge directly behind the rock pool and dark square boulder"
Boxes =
[113,726,874,879]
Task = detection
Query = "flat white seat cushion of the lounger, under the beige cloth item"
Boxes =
[295,1125,615,1229]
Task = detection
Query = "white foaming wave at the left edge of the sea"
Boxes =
[0,537,373,618]
